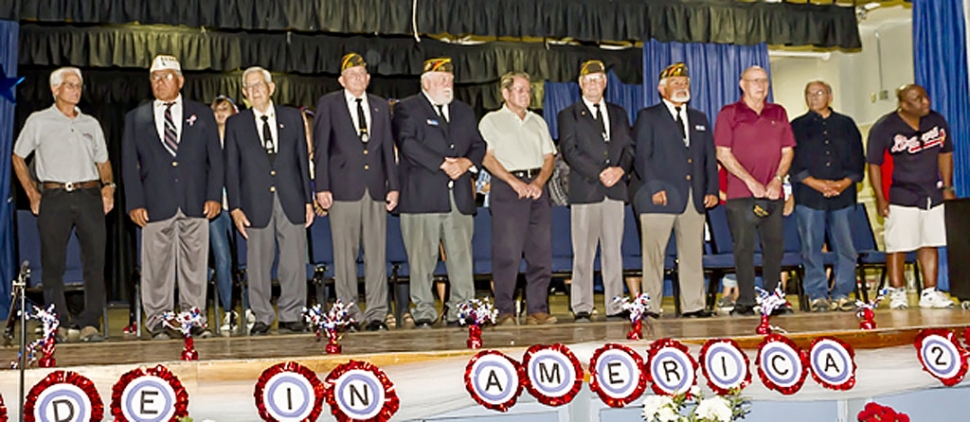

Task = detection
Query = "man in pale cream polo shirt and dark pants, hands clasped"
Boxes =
[478,72,556,325]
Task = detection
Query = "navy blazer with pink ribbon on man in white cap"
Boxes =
[121,98,223,222]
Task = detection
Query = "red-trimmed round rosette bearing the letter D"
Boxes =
[23,371,104,422]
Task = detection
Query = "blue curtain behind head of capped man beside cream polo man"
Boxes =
[542,71,644,139]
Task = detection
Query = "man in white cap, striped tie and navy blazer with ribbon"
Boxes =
[121,55,223,339]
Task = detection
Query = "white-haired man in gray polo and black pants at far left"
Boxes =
[13,67,115,342]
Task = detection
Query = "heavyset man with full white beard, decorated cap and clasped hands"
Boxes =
[394,58,485,328]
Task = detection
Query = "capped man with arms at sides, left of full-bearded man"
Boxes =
[313,53,399,331]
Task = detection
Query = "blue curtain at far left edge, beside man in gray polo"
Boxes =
[0,20,20,318]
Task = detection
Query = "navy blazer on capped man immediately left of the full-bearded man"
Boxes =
[313,90,399,202]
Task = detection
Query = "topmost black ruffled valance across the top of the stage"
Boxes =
[0,0,862,49]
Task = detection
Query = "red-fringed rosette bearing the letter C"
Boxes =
[755,334,808,396]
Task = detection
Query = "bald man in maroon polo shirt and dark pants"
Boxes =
[714,66,795,315]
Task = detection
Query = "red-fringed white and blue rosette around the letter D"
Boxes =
[23,371,104,422]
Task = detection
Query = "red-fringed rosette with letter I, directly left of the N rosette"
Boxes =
[253,362,324,422]
